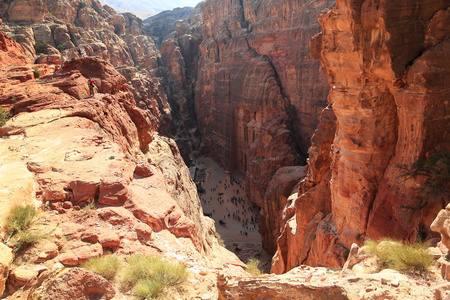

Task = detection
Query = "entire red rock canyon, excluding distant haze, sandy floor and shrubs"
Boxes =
[0,0,450,299]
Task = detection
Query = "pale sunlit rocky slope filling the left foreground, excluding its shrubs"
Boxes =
[0,28,246,299]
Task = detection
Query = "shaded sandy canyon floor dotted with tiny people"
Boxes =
[193,157,262,262]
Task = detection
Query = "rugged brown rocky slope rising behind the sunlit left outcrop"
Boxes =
[0,0,171,132]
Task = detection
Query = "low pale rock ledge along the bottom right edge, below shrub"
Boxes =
[218,256,448,300]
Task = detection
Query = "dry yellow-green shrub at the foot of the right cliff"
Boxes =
[364,239,434,271]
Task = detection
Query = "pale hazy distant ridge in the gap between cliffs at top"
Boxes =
[100,0,200,14]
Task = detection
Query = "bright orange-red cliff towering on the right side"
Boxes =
[272,0,450,272]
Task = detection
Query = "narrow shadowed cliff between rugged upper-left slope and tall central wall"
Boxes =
[156,6,203,164]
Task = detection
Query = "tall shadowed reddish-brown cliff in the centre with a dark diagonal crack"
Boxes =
[195,1,332,206]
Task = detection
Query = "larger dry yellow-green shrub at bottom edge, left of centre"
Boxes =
[124,254,188,298]
